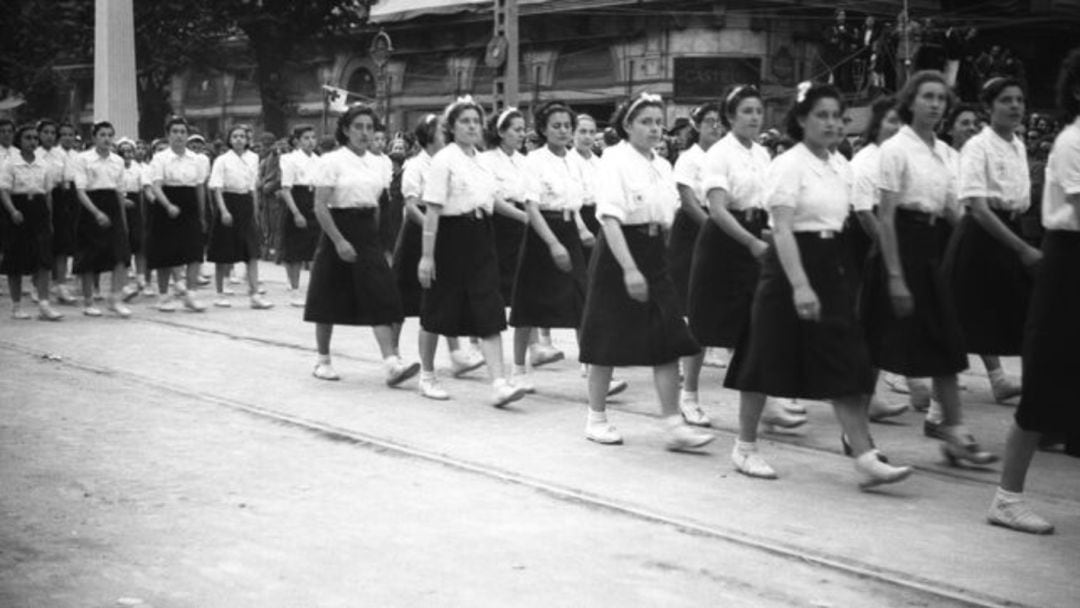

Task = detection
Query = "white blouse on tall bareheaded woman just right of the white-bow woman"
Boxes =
[878,125,957,215]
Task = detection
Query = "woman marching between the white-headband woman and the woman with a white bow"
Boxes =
[680,85,806,436]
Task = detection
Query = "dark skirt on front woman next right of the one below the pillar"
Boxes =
[146,186,203,269]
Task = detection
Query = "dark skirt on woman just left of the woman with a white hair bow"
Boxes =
[687,211,768,348]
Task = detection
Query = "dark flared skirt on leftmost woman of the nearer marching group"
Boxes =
[303,208,405,326]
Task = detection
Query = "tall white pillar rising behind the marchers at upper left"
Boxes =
[94,0,138,138]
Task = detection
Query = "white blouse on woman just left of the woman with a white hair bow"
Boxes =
[704,133,772,211]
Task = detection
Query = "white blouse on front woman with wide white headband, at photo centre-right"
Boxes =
[596,141,679,227]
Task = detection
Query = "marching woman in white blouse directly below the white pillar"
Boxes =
[71,122,132,317]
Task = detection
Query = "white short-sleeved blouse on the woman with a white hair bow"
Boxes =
[765,144,852,232]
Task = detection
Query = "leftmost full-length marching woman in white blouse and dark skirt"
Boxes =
[0,125,64,321]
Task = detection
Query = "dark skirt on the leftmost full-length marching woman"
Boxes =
[0,194,53,276]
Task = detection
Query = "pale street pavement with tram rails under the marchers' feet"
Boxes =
[0,264,1080,607]
